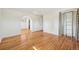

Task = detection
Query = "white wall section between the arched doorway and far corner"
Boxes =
[32,16,43,32]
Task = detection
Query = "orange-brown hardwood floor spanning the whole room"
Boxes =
[0,30,79,50]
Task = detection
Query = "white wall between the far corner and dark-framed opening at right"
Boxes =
[43,10,59,35]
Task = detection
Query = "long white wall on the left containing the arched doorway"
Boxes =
[0,9,42,38]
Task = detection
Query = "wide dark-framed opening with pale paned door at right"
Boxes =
[59,11,77,39]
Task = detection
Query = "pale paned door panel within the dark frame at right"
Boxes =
[63,12,73,37]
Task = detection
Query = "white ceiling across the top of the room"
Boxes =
[6,8,68,15]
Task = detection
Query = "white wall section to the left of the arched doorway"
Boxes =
[0,9,20,37]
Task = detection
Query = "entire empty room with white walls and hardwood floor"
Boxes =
[0,8,79,50]
